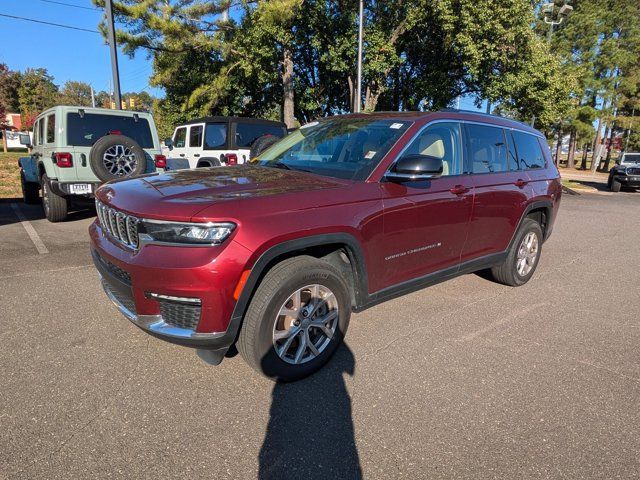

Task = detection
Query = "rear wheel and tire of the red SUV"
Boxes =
[491,218,542,287]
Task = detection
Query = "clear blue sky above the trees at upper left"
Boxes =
[0,0,162,96]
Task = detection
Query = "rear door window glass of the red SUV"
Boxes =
[466,124,509,173]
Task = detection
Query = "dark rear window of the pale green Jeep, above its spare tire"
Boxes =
[67,113,153,148]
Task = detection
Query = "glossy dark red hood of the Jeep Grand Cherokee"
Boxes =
[96,165,352,221]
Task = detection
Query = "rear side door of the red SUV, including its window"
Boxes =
[461,123,531,262]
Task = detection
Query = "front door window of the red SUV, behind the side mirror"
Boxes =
[403,122,463,177]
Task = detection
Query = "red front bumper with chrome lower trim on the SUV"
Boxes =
[89,222,248,354]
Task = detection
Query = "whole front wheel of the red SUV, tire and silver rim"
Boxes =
[236,256,351,382]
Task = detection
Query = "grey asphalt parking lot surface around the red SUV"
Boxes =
[0,192,640,479]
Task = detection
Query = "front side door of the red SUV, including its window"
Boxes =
[378,122,473,291]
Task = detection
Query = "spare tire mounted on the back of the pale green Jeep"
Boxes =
[89,135,147,182]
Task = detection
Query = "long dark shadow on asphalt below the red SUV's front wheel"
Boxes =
[258,344,362,480]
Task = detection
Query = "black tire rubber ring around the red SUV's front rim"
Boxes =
[254,268,351,382]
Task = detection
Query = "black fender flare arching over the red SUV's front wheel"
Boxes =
[225,233,368,342]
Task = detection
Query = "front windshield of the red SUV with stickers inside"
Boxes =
[256,118,412,180]
